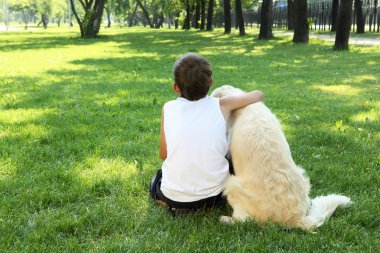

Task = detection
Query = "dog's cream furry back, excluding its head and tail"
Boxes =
[226,103,310,223]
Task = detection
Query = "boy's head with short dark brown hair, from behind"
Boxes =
[173,53,212,100]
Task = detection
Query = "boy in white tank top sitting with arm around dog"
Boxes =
[150,53,264,214]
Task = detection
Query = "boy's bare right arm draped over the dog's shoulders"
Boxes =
[219,90,264,119]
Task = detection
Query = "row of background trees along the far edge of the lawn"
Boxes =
[2,0,368,49]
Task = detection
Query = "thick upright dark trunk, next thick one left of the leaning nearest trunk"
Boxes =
[293,0,309,43]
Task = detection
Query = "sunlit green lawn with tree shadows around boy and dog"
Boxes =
[0,28,380,252]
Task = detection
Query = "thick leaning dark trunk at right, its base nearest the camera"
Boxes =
[334,0,353,50]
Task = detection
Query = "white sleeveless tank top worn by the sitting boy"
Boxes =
[161,96,229,202]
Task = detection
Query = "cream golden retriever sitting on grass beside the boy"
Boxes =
[211,85,350,230]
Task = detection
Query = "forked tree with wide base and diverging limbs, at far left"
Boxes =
[70,0,107,38]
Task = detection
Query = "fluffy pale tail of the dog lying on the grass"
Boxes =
[299,194,351,230]
